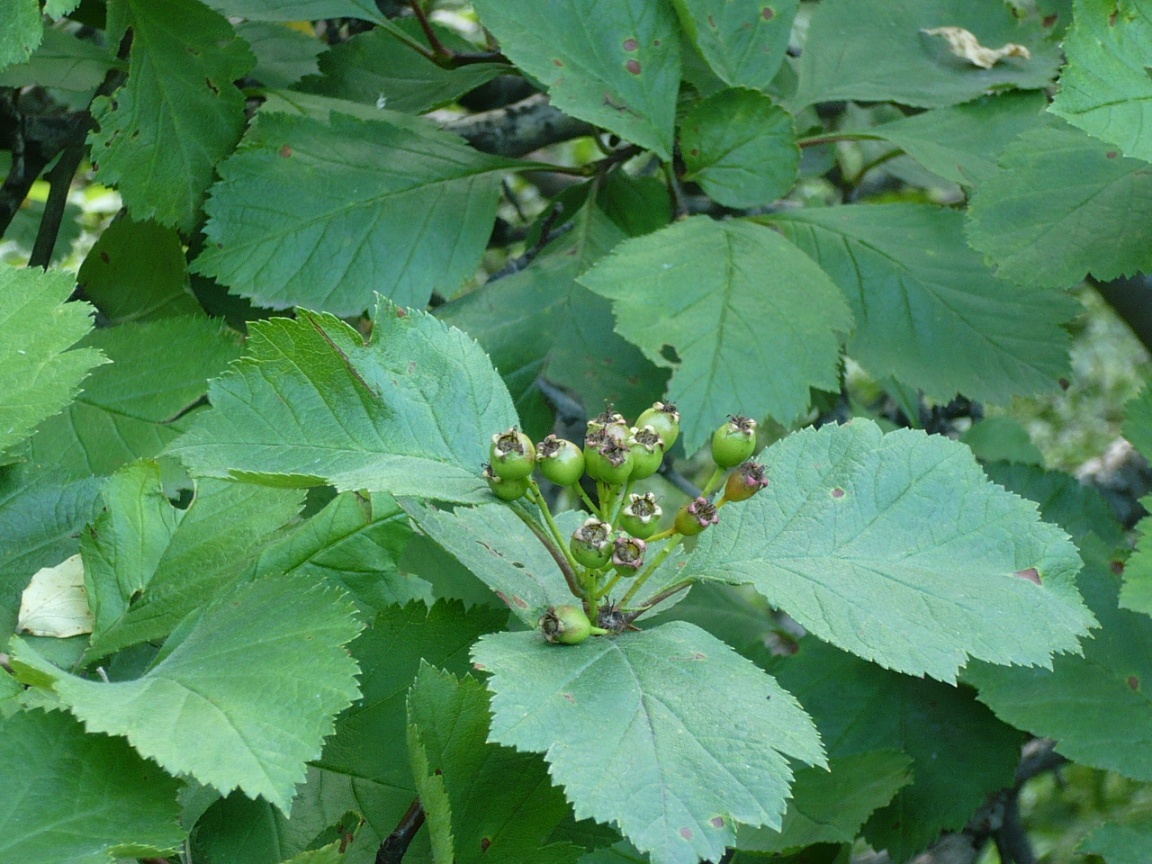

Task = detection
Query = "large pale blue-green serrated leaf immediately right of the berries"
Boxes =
[682,419,1094,681]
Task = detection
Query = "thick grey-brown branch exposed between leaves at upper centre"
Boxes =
[445,93,596,156]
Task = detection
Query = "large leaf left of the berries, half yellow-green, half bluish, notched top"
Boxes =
[169,303,516,502]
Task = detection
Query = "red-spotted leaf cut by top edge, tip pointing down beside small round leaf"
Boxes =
[475,0,680,160]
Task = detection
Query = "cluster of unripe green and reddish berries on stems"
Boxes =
[484,402,768,645]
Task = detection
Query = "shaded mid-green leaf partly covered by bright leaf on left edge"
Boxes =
[30,317,241,477]
